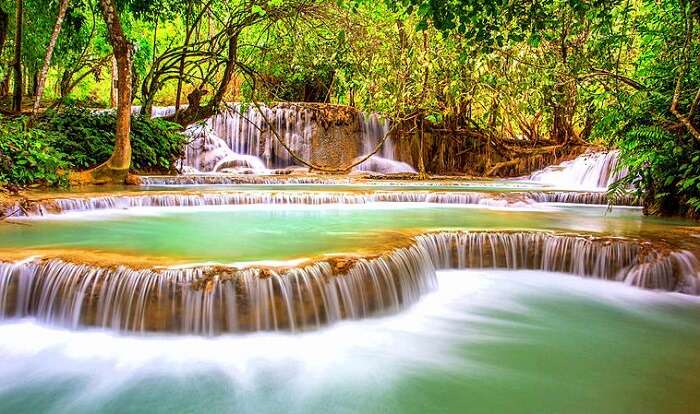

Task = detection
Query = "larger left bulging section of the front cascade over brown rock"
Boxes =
[0,246,435,335]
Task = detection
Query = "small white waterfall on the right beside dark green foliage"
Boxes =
[527,151,627,190]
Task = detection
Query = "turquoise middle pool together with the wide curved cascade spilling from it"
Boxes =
[0,202,700,335]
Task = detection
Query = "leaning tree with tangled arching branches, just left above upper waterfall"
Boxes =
[141,0,321,126]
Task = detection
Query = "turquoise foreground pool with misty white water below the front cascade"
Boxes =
[0,271,700,413]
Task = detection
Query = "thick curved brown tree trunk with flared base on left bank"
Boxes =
[73,0,132,184]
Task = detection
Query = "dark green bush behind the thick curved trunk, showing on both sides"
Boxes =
[37,108,187,173]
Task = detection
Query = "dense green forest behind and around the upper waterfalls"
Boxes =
[0,0,700,215]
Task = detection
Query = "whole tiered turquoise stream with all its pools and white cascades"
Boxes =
[0,146,700,413]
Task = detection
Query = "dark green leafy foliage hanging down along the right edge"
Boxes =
[594,0,700,216]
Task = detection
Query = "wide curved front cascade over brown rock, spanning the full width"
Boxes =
[0,232,700,335]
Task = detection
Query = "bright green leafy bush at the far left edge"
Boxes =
[0,117,70,186]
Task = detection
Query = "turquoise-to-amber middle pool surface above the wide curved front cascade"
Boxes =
[0,203,689,263]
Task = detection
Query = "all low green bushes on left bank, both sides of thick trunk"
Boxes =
[0,108,187,186]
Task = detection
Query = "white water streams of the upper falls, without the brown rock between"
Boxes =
[151,103,415,173]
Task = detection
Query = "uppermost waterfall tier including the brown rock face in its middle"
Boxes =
[146,103,415,173]
